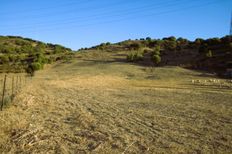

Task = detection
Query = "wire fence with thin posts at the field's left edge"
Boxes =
[0,74,29,111]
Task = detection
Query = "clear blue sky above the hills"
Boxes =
[0,0,232,50]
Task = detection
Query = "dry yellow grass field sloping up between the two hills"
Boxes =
[0,52,232,154]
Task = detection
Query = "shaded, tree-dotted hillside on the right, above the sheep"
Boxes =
[80,36,232,75]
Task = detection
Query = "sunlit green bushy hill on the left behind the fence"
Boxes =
[0,36,72,73]
